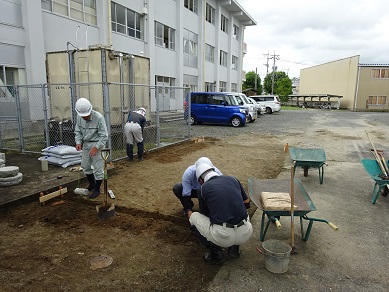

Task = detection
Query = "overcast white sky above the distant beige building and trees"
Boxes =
[238,0,389,81]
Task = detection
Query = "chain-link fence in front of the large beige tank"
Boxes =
[0,83,190,160]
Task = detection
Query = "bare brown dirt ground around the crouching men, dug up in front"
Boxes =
[0,134,286,291]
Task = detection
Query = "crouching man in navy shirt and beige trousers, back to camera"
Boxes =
[188,164,253,264]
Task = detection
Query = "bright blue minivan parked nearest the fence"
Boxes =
[190,92,248,127]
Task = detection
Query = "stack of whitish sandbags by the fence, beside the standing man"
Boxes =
[38,145,82,168]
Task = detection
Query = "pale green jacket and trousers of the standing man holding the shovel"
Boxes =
[74,110,108,180]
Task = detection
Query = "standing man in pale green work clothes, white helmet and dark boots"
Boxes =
[74,98,108,199]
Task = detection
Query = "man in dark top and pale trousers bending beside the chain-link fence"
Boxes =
[124,107,146,161]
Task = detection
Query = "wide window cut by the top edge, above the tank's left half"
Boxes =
[41,0,97,25]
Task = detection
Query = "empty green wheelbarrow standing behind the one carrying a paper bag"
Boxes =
[289,147,327,184]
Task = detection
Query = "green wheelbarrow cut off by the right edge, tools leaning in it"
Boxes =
[361,159,389,204]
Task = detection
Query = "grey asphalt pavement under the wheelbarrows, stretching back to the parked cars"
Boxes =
[206,109,389,291]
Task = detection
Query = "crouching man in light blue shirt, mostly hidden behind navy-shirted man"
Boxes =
[173,157,222,216]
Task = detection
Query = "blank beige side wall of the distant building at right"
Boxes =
[299,56,359,110]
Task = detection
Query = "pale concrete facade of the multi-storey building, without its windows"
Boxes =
[0,0,256,90]
